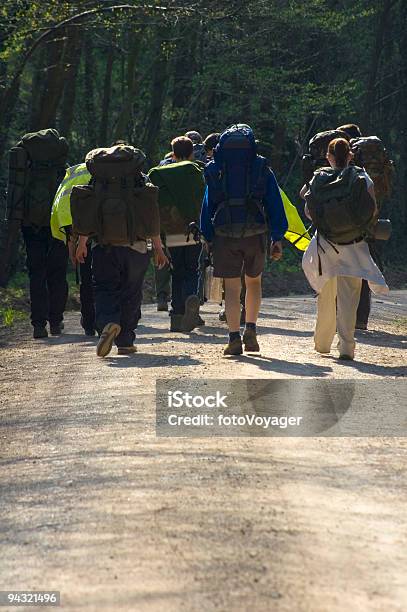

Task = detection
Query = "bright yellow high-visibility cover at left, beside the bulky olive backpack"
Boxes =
[51,163,91,243]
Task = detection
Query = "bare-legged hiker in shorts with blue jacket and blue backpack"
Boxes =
[201,124,288,355]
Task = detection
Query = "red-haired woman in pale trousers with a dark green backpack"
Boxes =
[301,138,388,360]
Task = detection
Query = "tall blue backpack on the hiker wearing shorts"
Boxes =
[205,124,269,238]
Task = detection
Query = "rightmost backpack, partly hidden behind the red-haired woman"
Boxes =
[350,136,394,203]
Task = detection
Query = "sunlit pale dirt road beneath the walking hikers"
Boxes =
[0,292,407,612]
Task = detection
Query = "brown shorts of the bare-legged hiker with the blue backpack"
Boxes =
[212,234,266,278]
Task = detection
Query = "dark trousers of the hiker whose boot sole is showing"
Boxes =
[92,245,150,346]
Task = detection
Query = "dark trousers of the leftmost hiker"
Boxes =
[22,226,68,327]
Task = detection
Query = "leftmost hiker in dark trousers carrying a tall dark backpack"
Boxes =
[7,129,68,338]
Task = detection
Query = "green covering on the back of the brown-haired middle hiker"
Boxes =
[148,161,205,235]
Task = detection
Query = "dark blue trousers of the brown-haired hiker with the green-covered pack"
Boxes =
[169,244,202,314]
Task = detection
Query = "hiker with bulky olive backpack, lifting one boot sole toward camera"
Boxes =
[71,145,167,357]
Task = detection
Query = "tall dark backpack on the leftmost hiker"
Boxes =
[6,129,68,227]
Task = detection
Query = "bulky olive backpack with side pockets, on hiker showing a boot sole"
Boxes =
[71,145,160,245]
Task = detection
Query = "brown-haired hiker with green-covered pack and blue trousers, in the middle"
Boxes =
[149,136,204,333]
